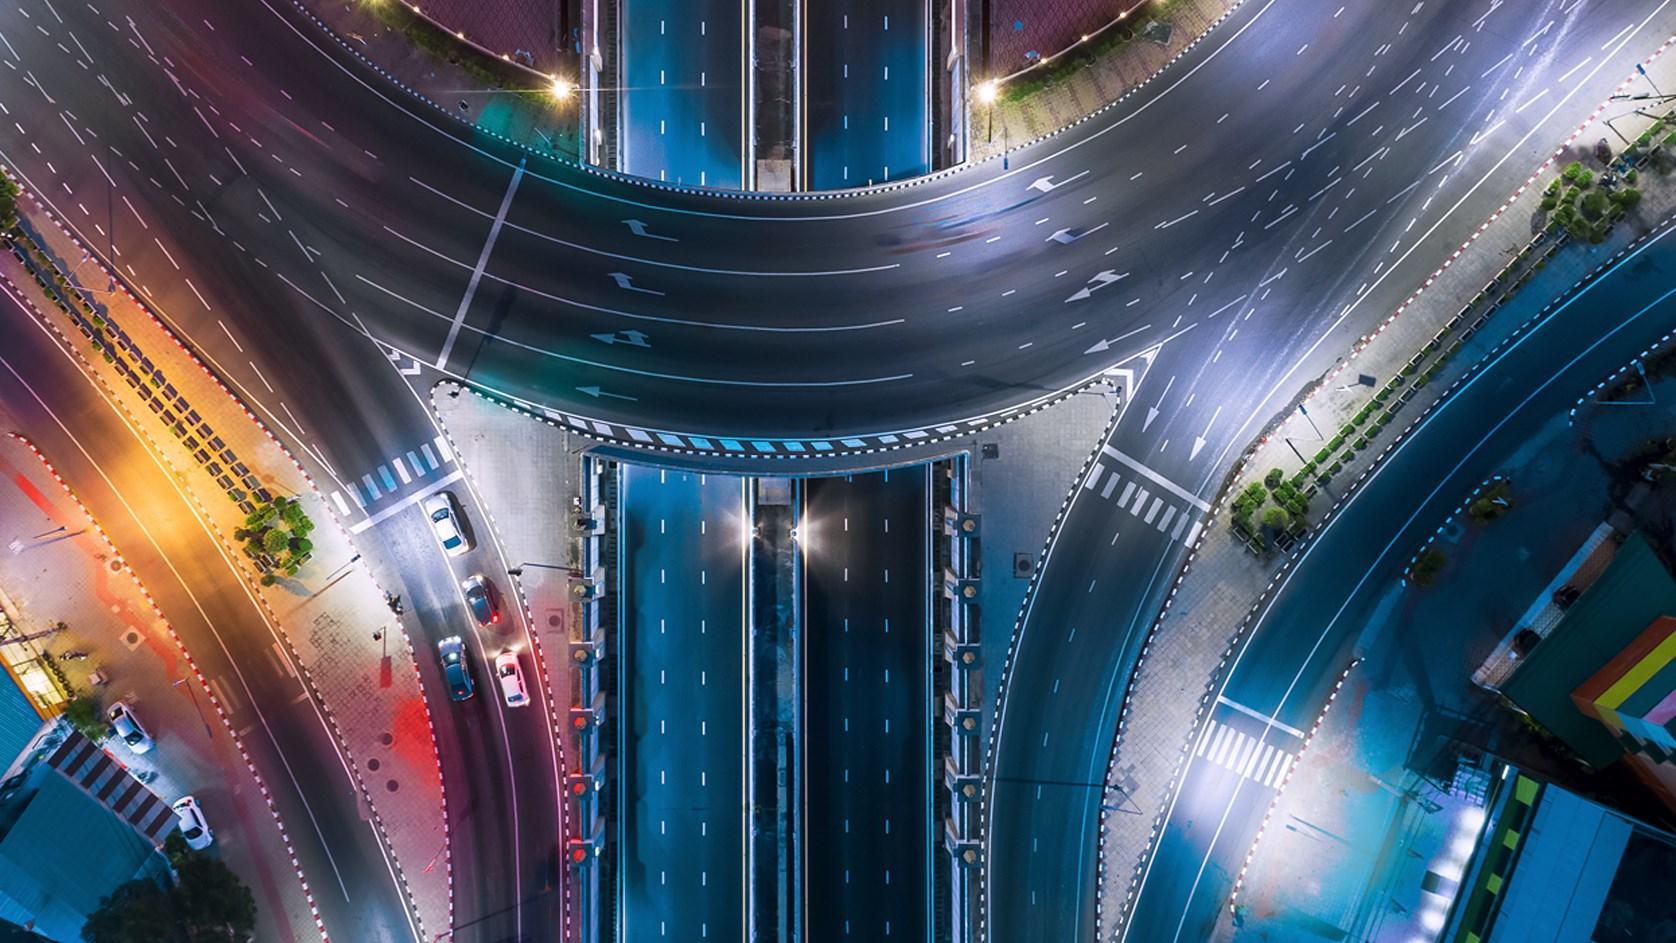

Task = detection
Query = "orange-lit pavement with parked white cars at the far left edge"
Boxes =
[0,428,318,940]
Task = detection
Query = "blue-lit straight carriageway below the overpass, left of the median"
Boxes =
[617,466,746,941]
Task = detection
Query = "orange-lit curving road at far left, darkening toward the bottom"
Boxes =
[0,291,417,943]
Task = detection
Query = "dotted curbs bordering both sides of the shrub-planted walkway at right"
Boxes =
[1094,35,1676,940]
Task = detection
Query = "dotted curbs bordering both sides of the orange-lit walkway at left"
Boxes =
[0,182,454,938]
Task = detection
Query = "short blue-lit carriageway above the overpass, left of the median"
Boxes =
[618,0,746,189]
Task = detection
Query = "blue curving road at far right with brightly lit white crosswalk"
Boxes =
[1128,216,1676,943]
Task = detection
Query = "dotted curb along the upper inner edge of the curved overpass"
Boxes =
[292,0,1245,203]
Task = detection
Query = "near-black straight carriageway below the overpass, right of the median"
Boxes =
[799,466,937,943]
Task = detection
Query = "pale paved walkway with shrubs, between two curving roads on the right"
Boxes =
[1099,33,1676,921]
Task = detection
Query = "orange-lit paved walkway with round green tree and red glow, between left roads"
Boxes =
[0,198,453,935]
